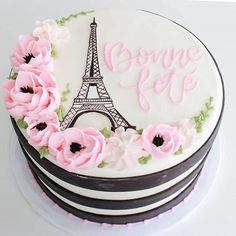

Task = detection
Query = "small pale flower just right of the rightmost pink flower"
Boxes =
[175,118,197,148]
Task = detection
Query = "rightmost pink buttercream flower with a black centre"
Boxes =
[142,124,181,157]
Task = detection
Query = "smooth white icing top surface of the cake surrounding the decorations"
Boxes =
[48,10,223,177]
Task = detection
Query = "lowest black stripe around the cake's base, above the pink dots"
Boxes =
[29,165,201,224]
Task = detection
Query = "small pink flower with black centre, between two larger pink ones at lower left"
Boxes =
[24,112,60,147]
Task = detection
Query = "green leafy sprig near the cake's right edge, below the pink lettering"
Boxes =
[193,97,214,133]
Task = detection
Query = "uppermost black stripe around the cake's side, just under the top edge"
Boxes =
[12,116,220,192]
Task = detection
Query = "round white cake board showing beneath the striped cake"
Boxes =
[9,134,221,236]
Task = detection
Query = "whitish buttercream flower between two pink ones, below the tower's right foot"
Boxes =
[104,127,148,170]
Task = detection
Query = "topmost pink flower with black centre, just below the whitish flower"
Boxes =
[11,35,53,72]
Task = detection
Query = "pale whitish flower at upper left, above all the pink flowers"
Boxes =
[33,19,70,45]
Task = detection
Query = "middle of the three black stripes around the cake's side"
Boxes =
[22,141,207,210]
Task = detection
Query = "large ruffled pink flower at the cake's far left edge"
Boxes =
[3,71,60,119]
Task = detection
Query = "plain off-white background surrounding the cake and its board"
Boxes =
[0,0,236,236]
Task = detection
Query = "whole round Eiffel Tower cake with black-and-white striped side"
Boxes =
[3,10,224,224]
